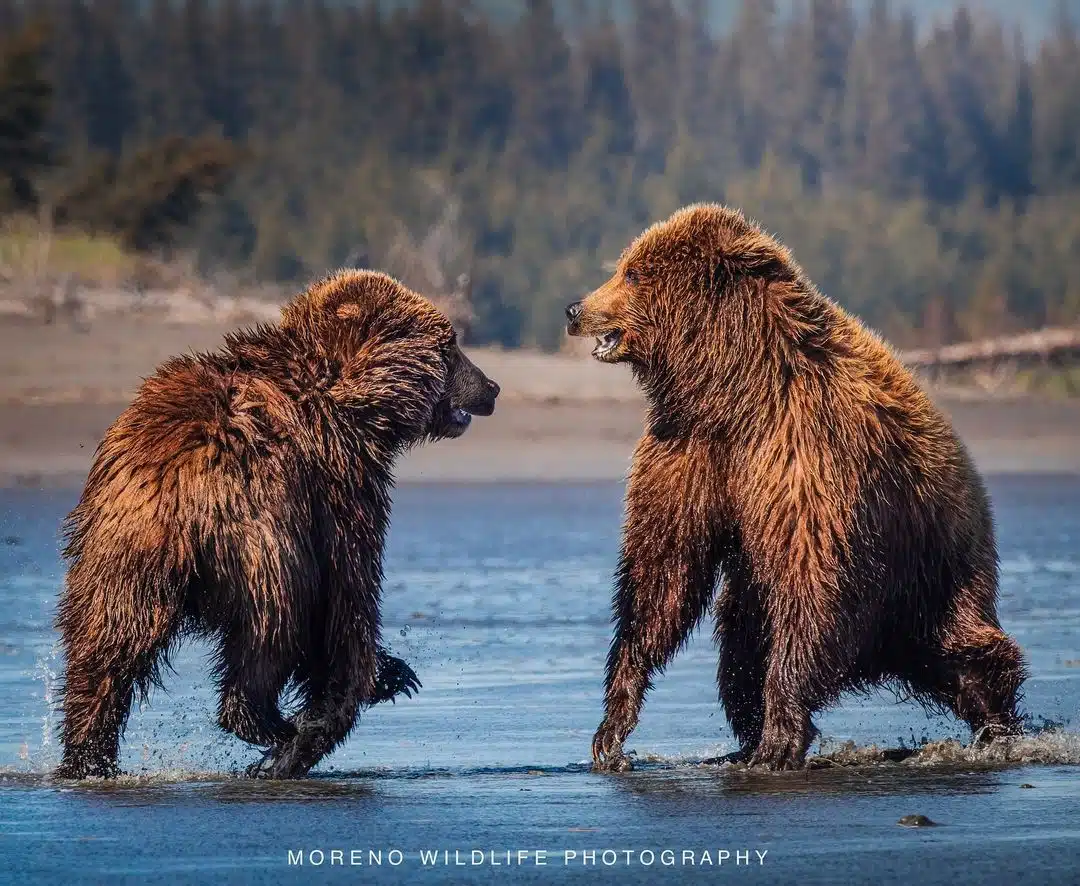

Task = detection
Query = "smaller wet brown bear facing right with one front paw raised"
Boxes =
[55,271,499,778]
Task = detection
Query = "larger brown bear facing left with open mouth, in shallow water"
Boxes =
[567,205,1025,770]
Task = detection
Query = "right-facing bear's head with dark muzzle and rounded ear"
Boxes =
[281,270,499,445]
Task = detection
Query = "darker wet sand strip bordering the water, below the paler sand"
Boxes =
[0,400,1080,488]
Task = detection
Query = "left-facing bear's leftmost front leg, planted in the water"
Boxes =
[592,434,721,771]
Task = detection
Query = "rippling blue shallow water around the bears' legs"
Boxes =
[0,476,1080,886]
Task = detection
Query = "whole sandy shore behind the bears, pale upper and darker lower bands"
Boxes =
[0,318,1080,488]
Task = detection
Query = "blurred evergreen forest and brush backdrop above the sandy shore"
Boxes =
[0,0,1080,348]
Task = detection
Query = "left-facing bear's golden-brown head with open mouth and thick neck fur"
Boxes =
[566,204,831,430]
